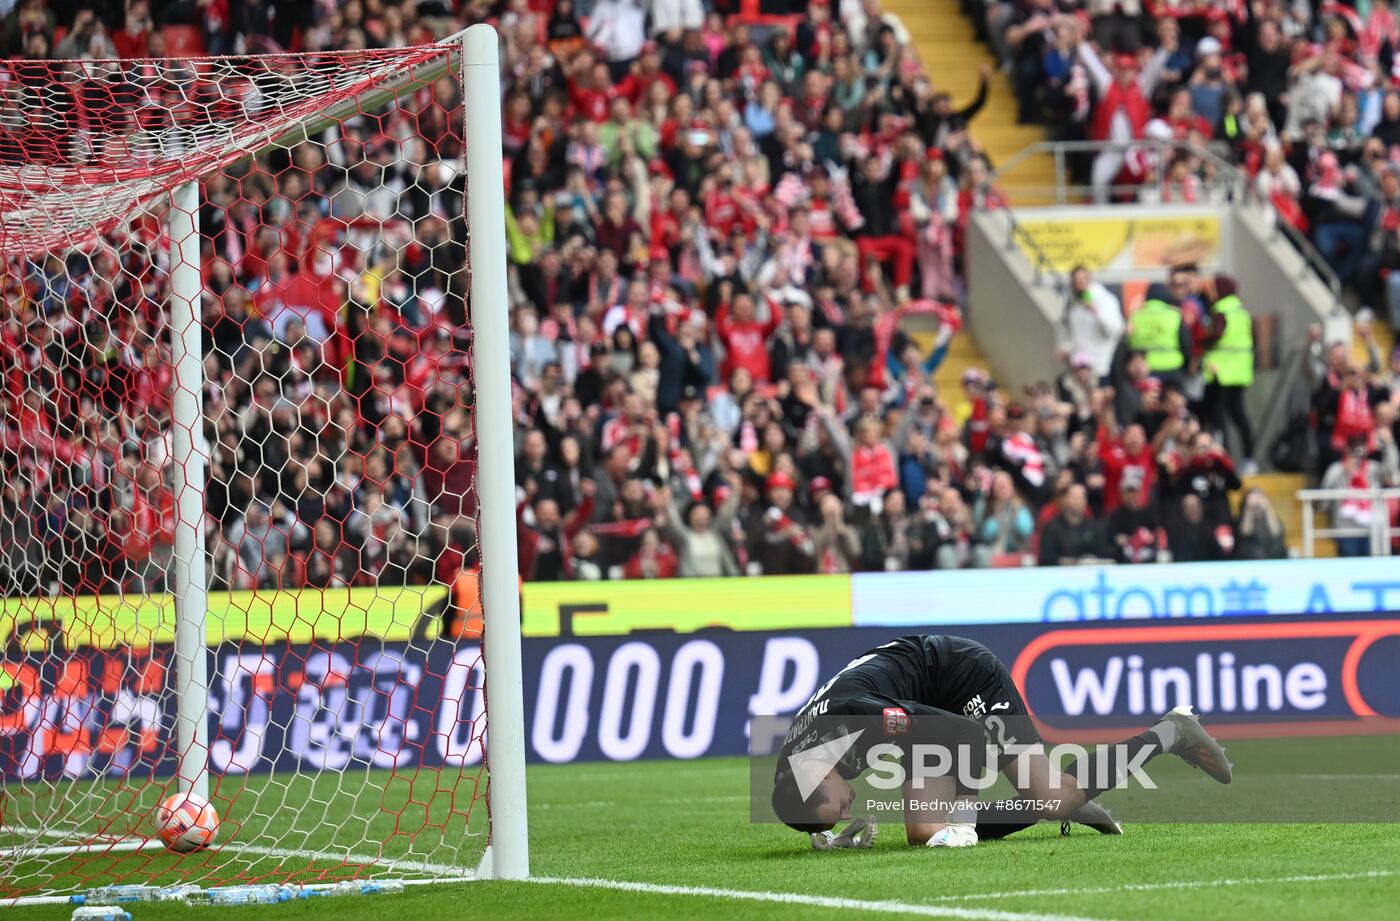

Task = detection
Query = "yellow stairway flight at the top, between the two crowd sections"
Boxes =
[883,0,1054,204]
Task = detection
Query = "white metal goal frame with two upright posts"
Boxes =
[0,24,529,890]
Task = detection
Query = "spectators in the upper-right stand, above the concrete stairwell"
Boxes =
[965,0,1400,329]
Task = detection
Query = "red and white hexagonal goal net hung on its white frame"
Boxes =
[0,27,525,900]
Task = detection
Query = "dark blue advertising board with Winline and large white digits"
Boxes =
[0,616,1400,780]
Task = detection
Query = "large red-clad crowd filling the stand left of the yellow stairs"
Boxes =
[8,0,1393,592]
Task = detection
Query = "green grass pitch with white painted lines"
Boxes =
[0,740,1400,921]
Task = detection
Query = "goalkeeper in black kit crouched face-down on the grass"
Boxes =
[773,635,1231,850]
